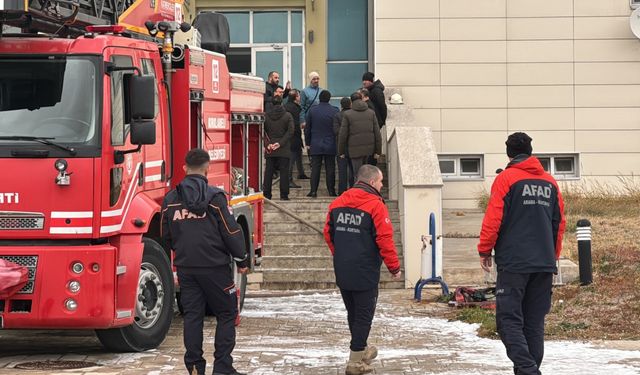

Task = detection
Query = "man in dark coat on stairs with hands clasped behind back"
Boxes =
[263,96,293,201]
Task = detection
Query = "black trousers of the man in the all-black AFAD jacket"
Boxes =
[178,266,238,374]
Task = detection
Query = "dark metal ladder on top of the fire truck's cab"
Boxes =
[0,0,135,37]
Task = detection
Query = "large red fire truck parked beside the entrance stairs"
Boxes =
[0,0,264,351]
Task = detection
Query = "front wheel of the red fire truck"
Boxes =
[96,238,174,352]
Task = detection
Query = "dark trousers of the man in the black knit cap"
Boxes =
[496,271,553,375]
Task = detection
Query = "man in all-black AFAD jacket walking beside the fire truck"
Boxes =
[160,149,249,375]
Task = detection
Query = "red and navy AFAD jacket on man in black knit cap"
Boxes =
[478,154,565,273]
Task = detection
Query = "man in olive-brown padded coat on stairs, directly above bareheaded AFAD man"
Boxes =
[338,92,382,171]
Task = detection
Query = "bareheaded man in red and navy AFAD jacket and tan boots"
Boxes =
[324,165,402,375]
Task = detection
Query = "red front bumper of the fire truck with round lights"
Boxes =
[0,245,117,329]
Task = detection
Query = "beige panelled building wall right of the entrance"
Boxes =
[375,0,640,207]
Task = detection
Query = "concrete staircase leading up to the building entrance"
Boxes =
[251,159,404,290]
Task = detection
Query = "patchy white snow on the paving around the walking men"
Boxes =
[239,293,640,375]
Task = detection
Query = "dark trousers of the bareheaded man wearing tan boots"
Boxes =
[340,287,378,352]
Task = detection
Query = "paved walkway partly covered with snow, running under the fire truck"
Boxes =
[0,290,640,375]
